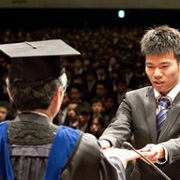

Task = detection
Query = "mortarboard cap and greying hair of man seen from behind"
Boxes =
[0,40,79,111]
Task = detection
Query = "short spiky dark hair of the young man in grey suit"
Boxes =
[141,25,180,62]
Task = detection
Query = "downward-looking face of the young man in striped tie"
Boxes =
[145,51,180,95]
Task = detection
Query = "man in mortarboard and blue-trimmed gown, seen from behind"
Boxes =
[0,39,138,180]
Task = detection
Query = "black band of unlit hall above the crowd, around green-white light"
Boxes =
[0,8,180,30]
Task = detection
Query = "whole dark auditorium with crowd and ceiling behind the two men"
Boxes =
[0,0,180,179]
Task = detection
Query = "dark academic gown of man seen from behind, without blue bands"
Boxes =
[3,113,125,180]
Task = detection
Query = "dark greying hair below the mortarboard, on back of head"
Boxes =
[10,79,60,111]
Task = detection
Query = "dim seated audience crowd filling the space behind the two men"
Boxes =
[0,26,149,138]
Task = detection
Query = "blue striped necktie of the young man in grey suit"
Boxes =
[156,97,171,136]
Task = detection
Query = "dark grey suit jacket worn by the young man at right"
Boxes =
[100,86,180,180]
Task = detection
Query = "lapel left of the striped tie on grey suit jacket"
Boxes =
[144,87,157,143]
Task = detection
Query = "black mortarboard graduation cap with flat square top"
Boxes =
[0,39,80,84]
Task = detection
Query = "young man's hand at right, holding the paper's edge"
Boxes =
[140,144,165,163]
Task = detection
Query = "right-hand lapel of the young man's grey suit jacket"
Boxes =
[158,93,180,142]
